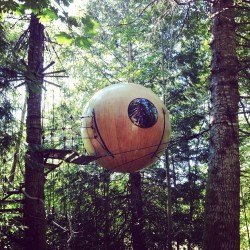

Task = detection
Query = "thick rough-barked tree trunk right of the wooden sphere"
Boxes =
[203,0,240,250]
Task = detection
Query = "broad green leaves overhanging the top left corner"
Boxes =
[0,0,99,49]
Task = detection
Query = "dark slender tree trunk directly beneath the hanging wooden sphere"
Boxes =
[129,172,146,250]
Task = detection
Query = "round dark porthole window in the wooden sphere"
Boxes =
[128,98,158,128]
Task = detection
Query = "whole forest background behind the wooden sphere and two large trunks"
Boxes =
[0,0,250,250]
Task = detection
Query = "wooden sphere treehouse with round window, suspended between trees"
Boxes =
[82,83,170,173]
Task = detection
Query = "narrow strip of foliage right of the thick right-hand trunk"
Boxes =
[236,1,250,249]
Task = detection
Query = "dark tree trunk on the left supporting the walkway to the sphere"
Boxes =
[24,15,46,250]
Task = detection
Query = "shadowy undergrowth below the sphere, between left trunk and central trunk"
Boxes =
[45,166,131,249]
